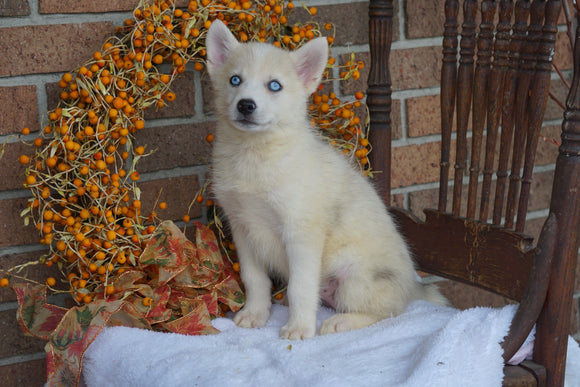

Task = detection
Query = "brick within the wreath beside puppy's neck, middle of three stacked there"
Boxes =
[136,122,215,172]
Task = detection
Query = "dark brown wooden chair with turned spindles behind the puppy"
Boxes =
[367,0,580,386]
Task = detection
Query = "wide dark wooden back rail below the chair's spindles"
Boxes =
[391,208,534,301]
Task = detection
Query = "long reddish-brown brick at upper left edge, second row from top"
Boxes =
[0,22,115,76]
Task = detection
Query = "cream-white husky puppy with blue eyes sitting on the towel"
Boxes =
[206,21,445,339]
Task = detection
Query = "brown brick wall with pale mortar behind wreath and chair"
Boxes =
[0,0,580,386]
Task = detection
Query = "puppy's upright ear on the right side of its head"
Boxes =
[290,38,328,94]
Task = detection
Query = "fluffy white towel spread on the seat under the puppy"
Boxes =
[83,301,580,387]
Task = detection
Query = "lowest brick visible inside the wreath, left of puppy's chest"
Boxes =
[139,175,201,221]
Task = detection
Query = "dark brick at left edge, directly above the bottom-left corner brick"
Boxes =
[0,310,46,358]
